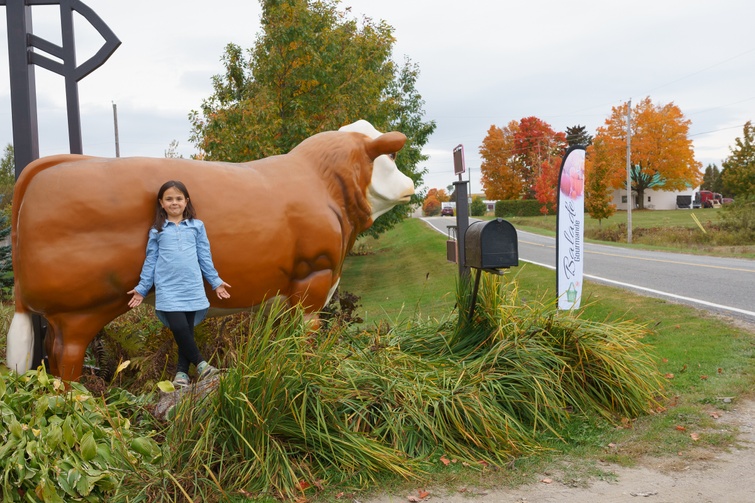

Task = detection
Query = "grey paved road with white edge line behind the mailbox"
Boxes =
[423,217,755,323]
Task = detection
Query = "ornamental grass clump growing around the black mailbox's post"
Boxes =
[449,275,663,420]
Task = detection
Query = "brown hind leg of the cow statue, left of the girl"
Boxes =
[47,302,127,381]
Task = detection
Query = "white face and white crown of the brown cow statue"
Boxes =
[339,120,414,221]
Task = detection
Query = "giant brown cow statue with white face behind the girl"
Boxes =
[6,121,414,380]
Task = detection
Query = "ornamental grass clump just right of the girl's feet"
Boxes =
[151,305,414,498]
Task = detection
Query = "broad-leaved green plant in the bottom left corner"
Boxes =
[0,367,162,503]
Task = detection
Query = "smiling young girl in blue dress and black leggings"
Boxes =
[128,180,231,386]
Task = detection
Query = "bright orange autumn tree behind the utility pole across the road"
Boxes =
[594,97,702,209]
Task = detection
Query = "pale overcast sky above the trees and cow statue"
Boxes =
[0,0,755,192]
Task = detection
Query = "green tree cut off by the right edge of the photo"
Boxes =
[721,121,755,198]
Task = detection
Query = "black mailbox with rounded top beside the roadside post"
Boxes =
[464,218,519,270]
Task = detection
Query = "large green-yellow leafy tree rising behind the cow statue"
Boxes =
[189,0,435,234]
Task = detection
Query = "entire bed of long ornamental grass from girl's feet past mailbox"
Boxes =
[149,278,661,501]
